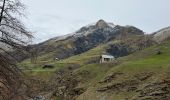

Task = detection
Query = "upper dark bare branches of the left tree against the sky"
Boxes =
[0,0,32,49]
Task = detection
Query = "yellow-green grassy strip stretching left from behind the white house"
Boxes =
[19,38,118,71]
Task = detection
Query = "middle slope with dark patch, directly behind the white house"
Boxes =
[58,36,156,64]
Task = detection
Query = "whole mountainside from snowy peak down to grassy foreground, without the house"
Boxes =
[18,20,170,100]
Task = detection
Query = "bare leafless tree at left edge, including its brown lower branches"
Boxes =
[0,0,32,100]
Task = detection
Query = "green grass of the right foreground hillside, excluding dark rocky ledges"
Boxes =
[78,41,170,100]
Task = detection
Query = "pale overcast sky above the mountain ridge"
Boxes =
[22,0,170,43]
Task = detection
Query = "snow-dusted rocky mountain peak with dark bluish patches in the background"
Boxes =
[29,20,144,60]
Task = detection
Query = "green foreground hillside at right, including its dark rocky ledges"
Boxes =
[74,41,170,100]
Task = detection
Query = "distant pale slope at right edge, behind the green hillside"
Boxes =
[153,26,170,42]
